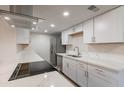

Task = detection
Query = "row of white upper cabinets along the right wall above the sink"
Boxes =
[62,6,124,45]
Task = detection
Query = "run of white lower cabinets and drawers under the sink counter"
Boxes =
[63,57,119,87]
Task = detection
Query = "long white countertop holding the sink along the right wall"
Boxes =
[57,53,124,72]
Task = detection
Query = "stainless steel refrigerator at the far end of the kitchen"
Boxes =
[50,33,66,67]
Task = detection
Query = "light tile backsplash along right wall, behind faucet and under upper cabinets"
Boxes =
[66,35,124,62]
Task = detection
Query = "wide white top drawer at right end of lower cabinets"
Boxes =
[88,65,117,82]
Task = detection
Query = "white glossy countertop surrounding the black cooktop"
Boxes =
[0,47,74,87]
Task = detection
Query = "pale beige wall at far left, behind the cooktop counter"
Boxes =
[0,17,16,65]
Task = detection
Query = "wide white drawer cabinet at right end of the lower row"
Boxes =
[88,65,117,87]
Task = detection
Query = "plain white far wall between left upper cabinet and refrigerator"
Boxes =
[31,32,51,62]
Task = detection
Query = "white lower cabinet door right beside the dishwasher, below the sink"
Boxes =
[62,57,69,76]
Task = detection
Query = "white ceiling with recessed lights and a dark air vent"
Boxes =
[33,5,117,33]
